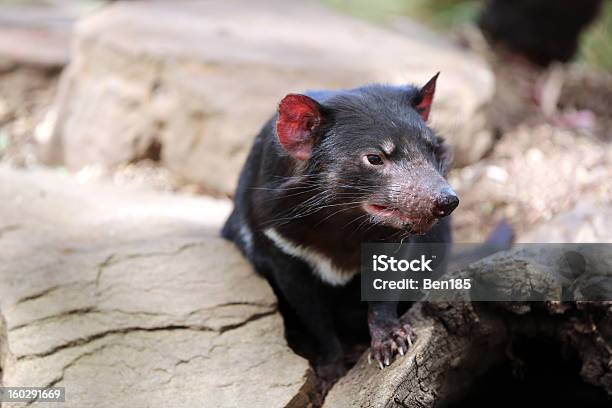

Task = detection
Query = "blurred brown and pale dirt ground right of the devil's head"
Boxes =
[450,53,612,242]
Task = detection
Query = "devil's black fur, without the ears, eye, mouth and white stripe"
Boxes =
[222,85,451,376]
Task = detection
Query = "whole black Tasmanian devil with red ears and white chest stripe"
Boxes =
[222,75,459,376]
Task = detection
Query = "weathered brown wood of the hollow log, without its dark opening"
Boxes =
[324,247,612,408]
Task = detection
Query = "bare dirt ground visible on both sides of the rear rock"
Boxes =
[0,58,612,242]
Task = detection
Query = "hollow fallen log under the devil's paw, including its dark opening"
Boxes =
[324,250,612,408]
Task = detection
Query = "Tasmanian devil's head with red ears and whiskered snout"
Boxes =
[276,75,459,234]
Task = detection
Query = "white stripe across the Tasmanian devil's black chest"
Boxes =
[264,228,359,286]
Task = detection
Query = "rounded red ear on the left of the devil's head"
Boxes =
[276,94,323,160]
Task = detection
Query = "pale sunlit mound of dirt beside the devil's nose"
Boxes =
[450,123,612,242]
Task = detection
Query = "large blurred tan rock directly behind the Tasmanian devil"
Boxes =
[41,0,494,193]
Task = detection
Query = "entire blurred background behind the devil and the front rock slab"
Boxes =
[0,0,612,241]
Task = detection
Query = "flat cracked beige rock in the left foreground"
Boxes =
[0,169,312,407]
